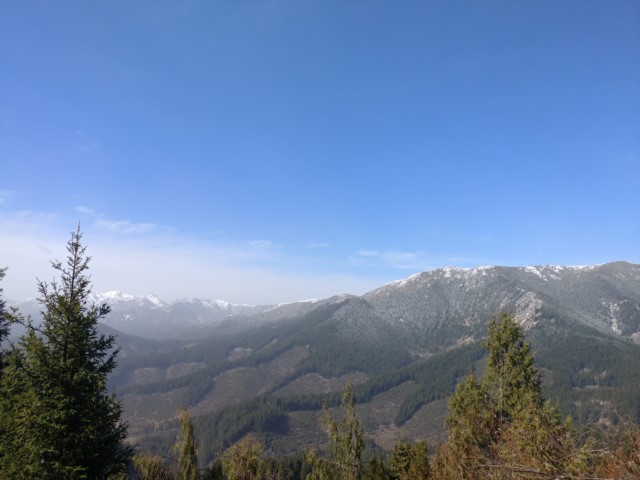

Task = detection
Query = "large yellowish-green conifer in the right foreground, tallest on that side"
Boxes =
[432,312,587,479]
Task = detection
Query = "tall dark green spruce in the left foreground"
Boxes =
[0,227,132,479]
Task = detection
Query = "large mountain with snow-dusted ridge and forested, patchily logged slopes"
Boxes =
[111,262,640,458]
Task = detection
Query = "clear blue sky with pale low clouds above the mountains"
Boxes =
[0,0,640,304]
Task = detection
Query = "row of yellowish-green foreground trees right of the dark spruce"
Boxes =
[134,312,640,480]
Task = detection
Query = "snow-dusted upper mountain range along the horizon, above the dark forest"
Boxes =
[20,262,640,344]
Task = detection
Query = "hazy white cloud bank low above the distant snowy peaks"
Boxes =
[0,209,380,304]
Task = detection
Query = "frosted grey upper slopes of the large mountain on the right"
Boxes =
[235,262,640,353]
